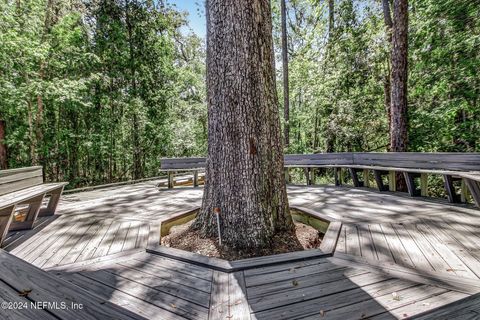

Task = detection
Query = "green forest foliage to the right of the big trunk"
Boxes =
[273,0,480,153]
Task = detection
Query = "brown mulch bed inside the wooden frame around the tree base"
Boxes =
[161,221,323,261]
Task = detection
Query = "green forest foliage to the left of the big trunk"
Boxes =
[0,0,206,187]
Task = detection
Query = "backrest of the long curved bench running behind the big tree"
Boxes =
[161,152,480,171]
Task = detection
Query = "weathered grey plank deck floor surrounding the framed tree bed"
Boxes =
[0,181,480,320]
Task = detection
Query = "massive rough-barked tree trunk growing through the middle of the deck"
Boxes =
[193,0,293,251]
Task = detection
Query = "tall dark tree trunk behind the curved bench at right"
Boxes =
[390,0,408,191]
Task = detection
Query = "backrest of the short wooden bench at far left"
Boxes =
[0,167,43,195]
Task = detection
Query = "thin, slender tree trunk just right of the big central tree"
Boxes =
[280,0,290,147]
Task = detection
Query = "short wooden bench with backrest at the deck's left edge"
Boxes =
[0,167,67,246]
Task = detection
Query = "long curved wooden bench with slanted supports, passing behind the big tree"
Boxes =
[158,152,480,207]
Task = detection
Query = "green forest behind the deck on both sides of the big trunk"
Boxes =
[0,0,480,188]
